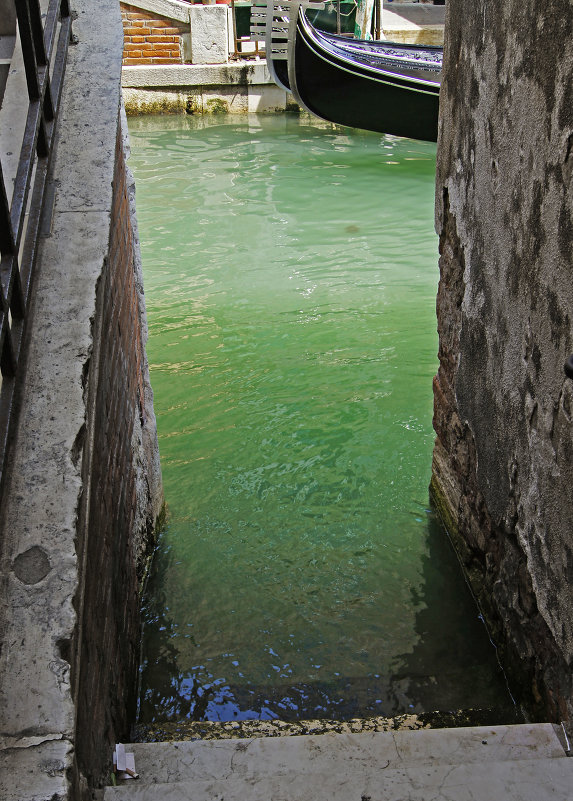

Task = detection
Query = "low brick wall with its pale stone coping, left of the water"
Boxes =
[0,0,162,801]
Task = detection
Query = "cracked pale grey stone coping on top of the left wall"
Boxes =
[0,0,161,801]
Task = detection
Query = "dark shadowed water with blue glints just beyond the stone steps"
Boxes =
[140,513,513,721]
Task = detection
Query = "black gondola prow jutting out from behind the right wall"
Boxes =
[250,3,442,142]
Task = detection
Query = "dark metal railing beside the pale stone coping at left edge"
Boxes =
[0,0,71,492]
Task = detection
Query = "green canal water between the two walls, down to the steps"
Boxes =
[130,116,509,722]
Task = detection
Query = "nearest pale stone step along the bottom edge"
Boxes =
[104,759,573,801]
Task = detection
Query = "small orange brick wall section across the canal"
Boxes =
[120,3,189,66]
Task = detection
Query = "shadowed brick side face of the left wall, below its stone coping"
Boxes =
[72,120,161,785]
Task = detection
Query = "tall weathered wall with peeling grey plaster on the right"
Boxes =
[432,0,573,720]
